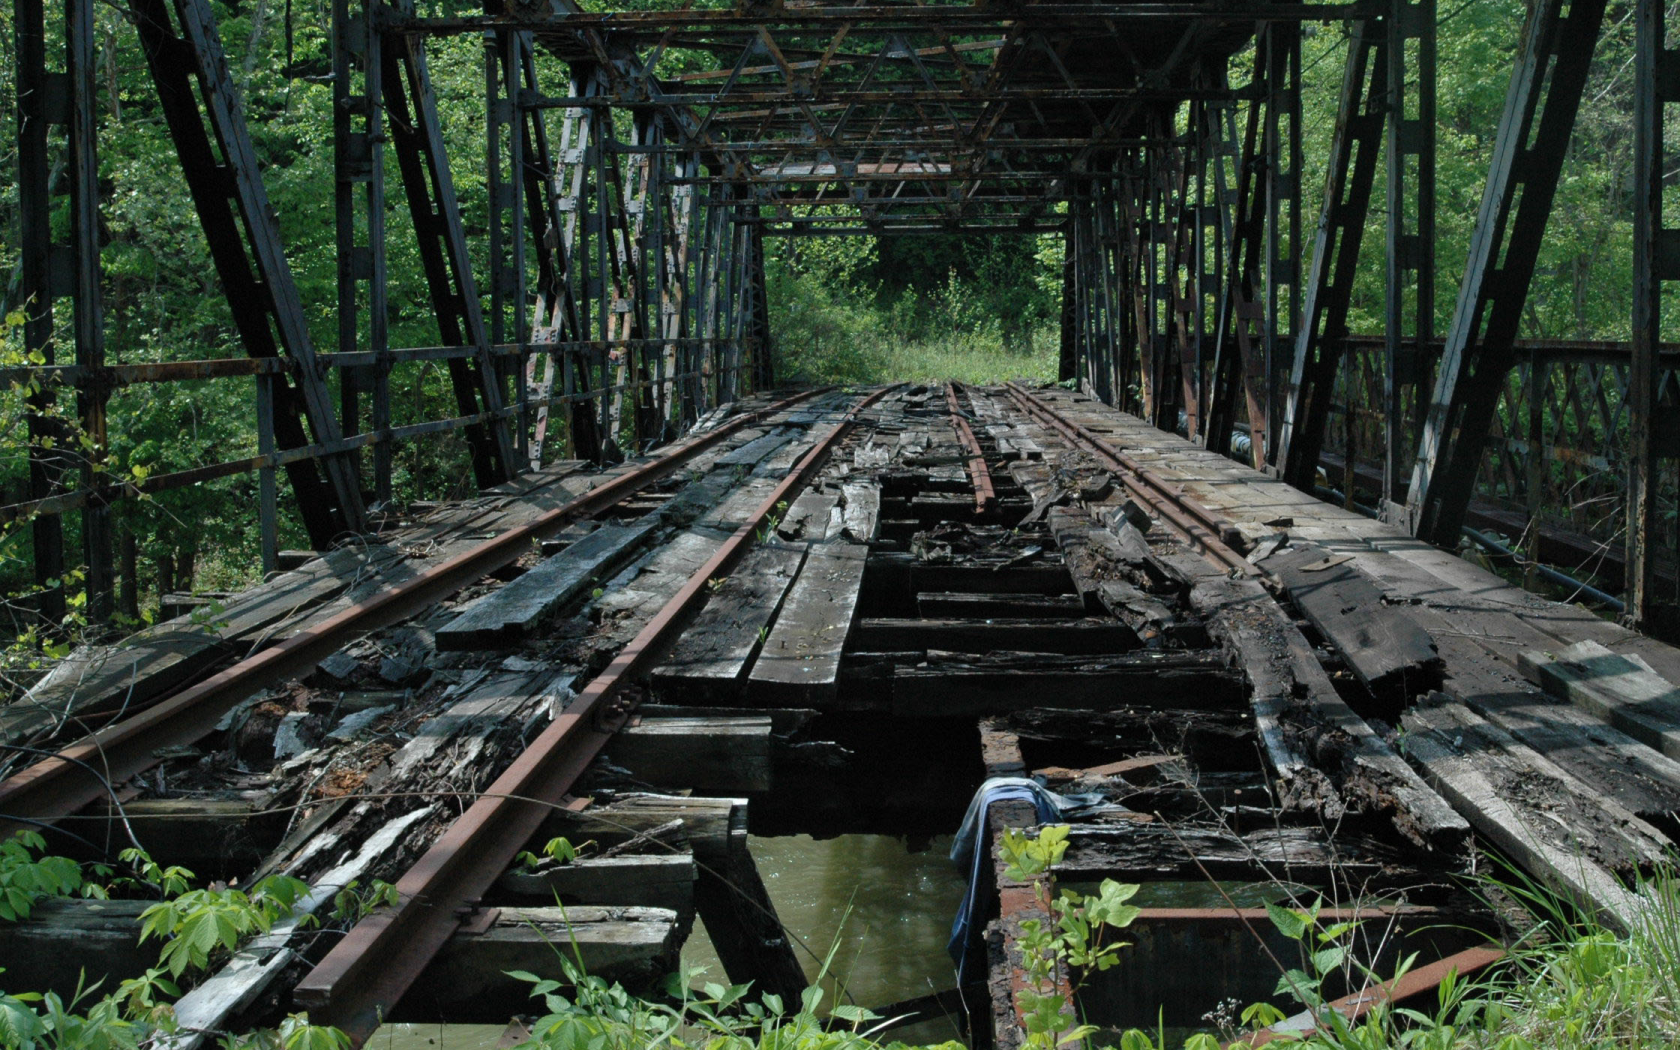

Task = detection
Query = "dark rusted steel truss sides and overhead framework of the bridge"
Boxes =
[0,0,1680,630]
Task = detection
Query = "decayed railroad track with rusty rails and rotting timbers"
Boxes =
[0,383,1680,1045]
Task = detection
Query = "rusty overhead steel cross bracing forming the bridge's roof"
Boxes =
[409,2,1368,235]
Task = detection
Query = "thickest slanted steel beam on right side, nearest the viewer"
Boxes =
[1406,0,1604,546]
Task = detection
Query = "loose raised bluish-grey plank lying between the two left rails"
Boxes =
[437,514,659,652]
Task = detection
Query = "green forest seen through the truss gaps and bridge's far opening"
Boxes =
[0,0,1653,631]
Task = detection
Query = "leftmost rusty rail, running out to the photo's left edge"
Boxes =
[0,388,823,832]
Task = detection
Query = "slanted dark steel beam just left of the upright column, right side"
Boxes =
[1278,20,1393,492]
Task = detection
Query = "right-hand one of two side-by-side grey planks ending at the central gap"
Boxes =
[748,543,869,707]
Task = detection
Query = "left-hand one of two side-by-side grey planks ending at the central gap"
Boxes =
[654,544,805,702]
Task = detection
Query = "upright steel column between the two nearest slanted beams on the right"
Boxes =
[1381,0,1435,519]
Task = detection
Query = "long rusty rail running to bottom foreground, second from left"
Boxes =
[296,386,892,1045]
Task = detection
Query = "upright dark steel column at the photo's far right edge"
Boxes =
[1626,0,1680,637]
